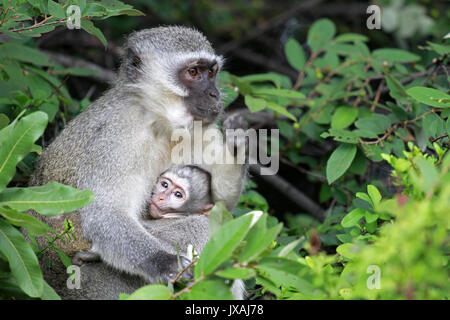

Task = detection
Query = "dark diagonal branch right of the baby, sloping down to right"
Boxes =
[250,164,324,221]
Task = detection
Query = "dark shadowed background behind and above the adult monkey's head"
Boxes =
[37,0,450,222]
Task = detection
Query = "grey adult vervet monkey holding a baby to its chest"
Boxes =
[31,27,245,296]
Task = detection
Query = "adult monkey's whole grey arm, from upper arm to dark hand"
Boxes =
[80,174,190,282]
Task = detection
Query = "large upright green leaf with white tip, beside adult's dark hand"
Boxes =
[195,212,255,278]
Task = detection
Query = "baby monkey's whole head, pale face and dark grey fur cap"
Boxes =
[149,165,214,219]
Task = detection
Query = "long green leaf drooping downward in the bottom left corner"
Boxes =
[0,219,44,297]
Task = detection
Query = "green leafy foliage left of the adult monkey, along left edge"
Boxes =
[0,0,141,299]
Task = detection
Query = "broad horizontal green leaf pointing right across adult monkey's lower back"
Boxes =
[0,182,94,216]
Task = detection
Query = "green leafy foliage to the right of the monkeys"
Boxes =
[128,19,450,299]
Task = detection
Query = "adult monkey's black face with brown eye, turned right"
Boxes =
[179,59,222,123]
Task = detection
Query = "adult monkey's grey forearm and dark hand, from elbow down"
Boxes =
[80,202,190,282]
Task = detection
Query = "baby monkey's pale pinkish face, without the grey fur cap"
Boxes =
[150,176,188,218]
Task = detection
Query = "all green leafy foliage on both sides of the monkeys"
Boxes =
[0,0,450,299]
